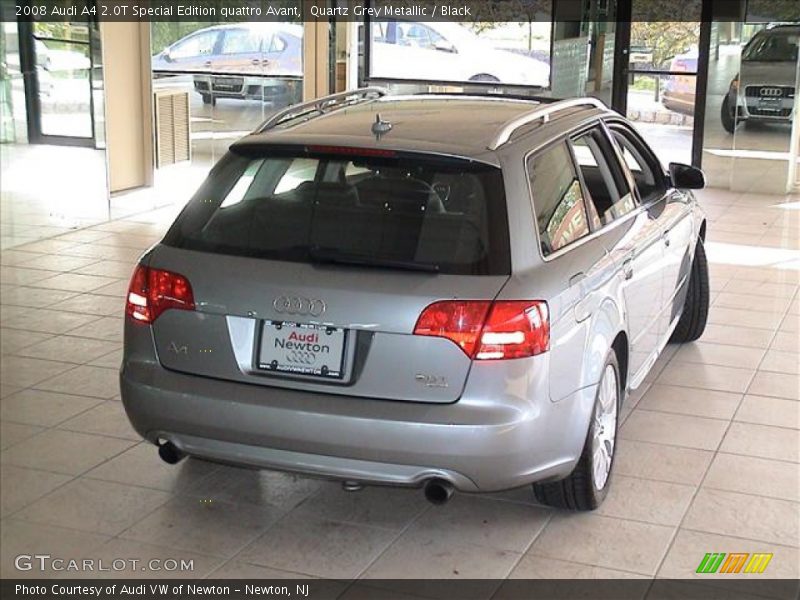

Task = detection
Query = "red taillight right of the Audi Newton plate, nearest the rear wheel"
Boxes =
[414,300,550,360]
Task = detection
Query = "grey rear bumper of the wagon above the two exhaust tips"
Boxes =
[120,355,595,492]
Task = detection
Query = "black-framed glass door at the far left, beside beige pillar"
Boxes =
[19,21,102,147]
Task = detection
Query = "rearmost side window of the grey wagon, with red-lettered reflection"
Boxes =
[527,143,589,256]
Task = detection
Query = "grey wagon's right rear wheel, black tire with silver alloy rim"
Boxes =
[533,350,622,511]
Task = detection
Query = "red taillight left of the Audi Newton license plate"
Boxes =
[125,265,194,323]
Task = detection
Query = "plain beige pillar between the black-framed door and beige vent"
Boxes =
[101,21,153,193]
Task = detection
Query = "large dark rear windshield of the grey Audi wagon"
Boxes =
[164,147,510,275]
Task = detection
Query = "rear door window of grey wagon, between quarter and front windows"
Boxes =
[572,128,636,225]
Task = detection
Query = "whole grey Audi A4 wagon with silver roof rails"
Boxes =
[121,88,708,509]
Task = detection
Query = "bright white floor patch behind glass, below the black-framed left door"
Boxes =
[0,144,109,248]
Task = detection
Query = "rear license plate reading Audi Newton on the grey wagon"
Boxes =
[258,321,345,379]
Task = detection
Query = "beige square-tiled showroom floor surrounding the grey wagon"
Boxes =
[0,190,800,579]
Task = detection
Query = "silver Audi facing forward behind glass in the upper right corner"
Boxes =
[721,25,800,133]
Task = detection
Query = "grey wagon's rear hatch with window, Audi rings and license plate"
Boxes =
[149,146,510,402]
